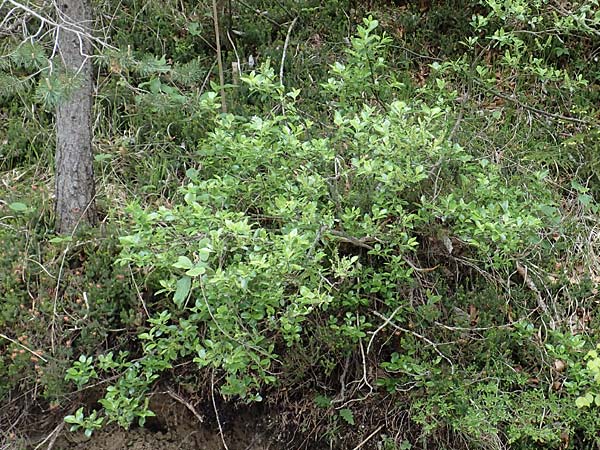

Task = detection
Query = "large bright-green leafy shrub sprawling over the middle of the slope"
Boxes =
[69,19,557,440]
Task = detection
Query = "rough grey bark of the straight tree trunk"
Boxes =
[55,0,97,233]
